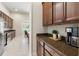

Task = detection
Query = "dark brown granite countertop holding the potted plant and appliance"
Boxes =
[37,33,79,56]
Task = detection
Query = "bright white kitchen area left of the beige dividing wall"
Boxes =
[0,2,30,56]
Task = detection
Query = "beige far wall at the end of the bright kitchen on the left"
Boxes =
[11,13,29,36]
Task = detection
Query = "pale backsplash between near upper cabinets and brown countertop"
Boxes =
[47,23,79,36]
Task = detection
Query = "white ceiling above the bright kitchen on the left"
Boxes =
[2,2,31,13]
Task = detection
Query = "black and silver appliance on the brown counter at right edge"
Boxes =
[66,27,79,47]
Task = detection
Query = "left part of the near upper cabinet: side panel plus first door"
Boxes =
[43,2,65,25]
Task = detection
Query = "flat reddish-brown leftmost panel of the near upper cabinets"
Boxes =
[42,2,53,25]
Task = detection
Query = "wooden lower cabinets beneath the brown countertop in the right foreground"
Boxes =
[37,38,60,56]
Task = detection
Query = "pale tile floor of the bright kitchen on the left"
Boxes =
[2,36,29,56]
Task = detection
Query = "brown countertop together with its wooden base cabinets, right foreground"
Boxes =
[37,33,79,56]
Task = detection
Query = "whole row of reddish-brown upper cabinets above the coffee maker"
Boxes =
[43,2,79,25]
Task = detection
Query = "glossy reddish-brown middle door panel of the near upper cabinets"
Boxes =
[53,2,64,24]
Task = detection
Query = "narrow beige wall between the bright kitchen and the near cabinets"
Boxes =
[32,2,46,55]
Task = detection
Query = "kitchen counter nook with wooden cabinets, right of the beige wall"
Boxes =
[36,2,79,56]
